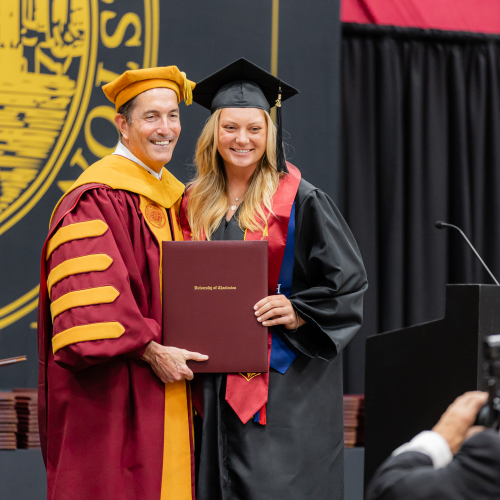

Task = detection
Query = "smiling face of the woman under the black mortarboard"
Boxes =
[217,108,267,172]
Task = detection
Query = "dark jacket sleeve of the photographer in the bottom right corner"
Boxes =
[366,430,500,500]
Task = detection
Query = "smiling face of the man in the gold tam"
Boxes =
[115,88,181,172]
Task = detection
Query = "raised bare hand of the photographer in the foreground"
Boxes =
[432,391,488,454]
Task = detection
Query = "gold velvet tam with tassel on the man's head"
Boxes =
[102,66,196,111]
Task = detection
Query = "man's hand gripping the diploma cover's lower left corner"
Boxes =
[142,341,208,384]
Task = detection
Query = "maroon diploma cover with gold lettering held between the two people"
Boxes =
[162,241,268,373]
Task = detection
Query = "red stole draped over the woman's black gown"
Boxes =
[181,162,301,425]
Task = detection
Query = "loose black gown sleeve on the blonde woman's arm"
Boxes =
[279,180,368,360]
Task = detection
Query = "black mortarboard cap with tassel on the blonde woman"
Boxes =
[193,57,299,172]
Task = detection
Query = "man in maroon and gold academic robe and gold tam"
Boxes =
[38,66,206,500]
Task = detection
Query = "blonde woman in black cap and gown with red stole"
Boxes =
[181,59,367,500]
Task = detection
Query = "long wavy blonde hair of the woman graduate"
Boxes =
[187,109,280,240]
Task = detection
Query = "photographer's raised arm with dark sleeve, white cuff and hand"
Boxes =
[366,391,500,500]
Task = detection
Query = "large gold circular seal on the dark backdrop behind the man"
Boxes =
[0,0,160,330]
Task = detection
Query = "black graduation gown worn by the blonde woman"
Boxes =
[195,179,367,500]
